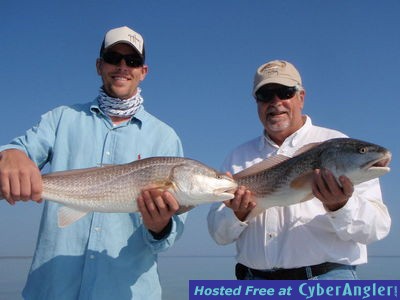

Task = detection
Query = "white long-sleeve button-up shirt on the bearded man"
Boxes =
[208,117,391,270]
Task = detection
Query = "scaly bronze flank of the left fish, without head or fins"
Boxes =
[42,157,203,212]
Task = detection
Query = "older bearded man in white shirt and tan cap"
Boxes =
[208,60,391,280]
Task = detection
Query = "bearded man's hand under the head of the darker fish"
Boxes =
[312,169,354,211]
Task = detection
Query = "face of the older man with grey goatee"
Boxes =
[257,84,305,145]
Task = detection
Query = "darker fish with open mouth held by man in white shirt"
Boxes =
[233,138,392,219]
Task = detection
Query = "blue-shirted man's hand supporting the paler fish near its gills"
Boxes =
[137,189,179,234]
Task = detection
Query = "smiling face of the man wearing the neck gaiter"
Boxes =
[96,43,148,99]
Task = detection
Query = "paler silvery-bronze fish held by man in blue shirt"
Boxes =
[5,157,237,227]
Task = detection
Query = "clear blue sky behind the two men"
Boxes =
[0,0,400,256]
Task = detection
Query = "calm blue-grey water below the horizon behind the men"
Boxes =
[0,255,400,300]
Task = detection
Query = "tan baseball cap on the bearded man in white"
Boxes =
[253,60,301,96]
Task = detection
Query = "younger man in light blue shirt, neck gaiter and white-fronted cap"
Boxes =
[0,27,185,300]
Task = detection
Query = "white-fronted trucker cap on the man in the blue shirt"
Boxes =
[100,26,145,61]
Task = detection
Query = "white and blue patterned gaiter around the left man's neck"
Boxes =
[97,87,143,117]
